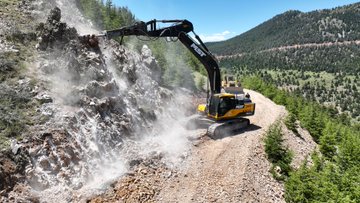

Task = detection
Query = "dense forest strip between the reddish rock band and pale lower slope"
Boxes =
[220,43,360,74]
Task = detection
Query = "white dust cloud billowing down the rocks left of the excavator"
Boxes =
[27,0,197,202]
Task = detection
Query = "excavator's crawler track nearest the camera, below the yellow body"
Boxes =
[207,118,250,139]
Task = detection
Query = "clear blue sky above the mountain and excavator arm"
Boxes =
[113,0,358,41]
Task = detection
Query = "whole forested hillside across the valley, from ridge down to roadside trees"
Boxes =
[208,3,360,120]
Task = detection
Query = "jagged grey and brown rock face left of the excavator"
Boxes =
[0,3,188,202]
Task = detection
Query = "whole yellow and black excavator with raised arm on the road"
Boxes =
[88,20,255,139]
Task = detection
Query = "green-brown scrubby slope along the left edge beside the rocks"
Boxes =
[0,0,41,151]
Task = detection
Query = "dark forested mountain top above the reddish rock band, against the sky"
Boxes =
[207,3,360,55]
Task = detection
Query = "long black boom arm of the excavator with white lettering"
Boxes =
[104,20,221,94]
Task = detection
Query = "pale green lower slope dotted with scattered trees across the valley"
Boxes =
[226,67,360,122]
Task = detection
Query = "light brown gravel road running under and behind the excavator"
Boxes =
[157,91,286,202]
